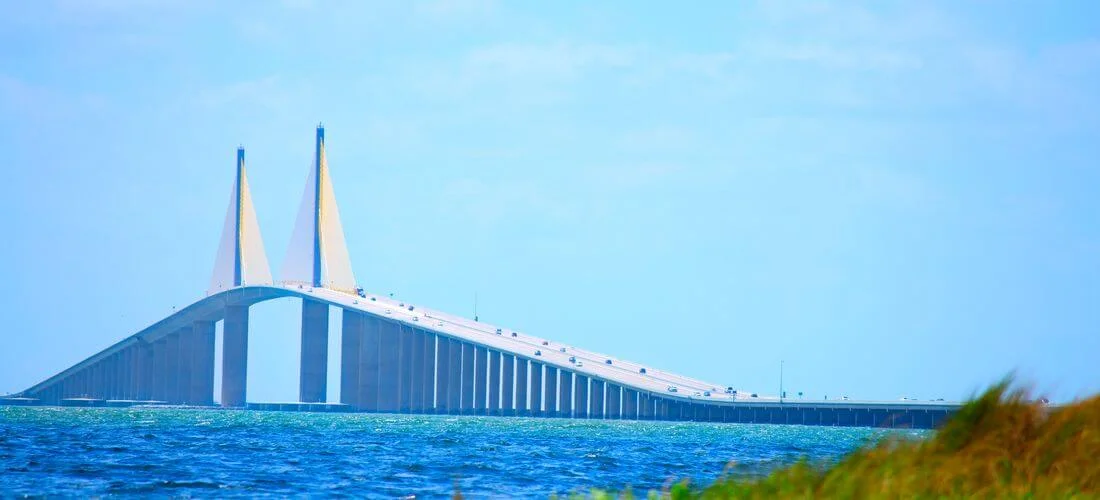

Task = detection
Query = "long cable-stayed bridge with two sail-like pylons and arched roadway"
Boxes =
[3,126,957,429]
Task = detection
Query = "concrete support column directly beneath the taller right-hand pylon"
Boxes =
[298,299,329,403]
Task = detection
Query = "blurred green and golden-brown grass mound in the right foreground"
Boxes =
[572,379,1100,500]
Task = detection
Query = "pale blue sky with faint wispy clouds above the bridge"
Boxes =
[0,0,1100,401]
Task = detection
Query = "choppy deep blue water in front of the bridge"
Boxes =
[0,408,922,498]
